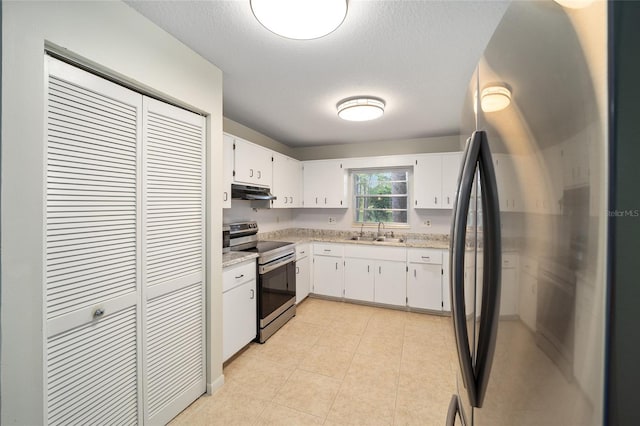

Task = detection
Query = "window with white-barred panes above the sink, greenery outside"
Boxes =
[353,169,409,225]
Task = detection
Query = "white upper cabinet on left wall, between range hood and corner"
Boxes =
[271,152,302,208]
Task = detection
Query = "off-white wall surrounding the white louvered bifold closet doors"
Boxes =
[1,1,222,425]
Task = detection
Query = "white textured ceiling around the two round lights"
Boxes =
[127,0,508,146]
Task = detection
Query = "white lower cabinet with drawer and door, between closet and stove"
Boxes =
[222,259,257,361]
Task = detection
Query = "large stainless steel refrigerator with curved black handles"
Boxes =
[447,0,608,426]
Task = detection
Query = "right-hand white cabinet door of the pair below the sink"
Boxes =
[374,260,407,306]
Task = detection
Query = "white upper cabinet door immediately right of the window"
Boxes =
[413,154,443,209]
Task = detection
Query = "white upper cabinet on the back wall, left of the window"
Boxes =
[303,160,348,208]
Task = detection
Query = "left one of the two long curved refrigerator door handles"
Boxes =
[449,132,481,406]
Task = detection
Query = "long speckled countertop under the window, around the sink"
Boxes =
[258,228,449,249]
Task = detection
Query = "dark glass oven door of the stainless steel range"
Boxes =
[258,257,296,328]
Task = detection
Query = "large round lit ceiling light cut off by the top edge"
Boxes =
[250,0,347,40]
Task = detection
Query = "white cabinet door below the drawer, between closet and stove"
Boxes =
[222,279,257,361]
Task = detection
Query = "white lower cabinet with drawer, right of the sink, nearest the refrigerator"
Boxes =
[407,249,443,311]
